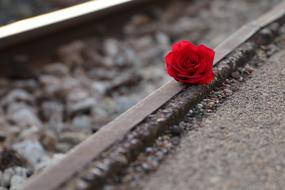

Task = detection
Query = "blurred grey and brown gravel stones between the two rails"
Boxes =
[0,0,278,189]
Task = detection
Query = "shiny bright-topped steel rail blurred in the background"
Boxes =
[0,0,151,50]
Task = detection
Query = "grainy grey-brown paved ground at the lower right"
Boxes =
[141,50,285,190]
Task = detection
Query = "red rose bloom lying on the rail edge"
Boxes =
[166,40,215,84]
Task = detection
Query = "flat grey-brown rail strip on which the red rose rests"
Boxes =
[20,1,285,190]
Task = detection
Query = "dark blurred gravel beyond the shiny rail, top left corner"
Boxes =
[0,0,86,26]
